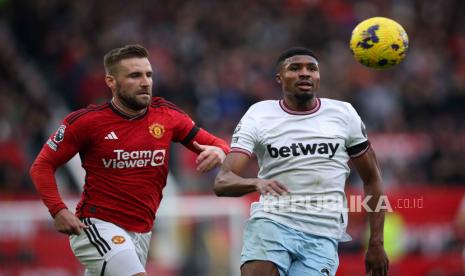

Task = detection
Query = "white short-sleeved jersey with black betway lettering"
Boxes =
[231,98,369,241]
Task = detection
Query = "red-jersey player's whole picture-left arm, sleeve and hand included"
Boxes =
[30,114,87,235]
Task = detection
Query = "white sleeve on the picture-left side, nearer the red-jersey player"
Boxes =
[231,108,258,156]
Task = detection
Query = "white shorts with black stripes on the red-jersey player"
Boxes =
[70,218,152,276]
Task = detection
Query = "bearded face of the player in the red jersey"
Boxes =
[109,58,153,111]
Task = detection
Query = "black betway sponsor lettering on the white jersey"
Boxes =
[266,143,339,158]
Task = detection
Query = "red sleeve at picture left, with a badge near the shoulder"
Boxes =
[30,115,85,217]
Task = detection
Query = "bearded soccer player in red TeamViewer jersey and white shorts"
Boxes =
[30,45,229,276]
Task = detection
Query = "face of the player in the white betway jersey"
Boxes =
[276,55,320,101]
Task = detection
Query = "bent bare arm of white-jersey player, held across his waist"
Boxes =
[214,152,289,197]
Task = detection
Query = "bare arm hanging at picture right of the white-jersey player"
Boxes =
[351,147,389,276]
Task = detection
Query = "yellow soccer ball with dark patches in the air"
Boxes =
[350,17,408,69]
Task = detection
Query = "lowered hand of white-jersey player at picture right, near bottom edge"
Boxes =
[365,244,389,276]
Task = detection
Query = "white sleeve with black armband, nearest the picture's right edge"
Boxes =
[346,104,370,157]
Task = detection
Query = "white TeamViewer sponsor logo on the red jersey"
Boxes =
[102,149,166,169]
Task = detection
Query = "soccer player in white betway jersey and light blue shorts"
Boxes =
[214,47,389,276]
